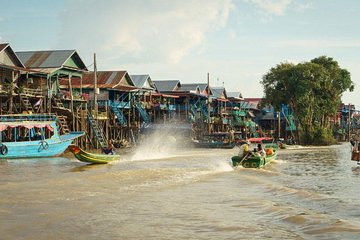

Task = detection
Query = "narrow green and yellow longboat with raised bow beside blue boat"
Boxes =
[69,145,120,164]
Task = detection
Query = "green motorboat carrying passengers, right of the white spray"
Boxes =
[231,146,278,168]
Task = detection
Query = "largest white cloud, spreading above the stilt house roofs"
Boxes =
[59,0,233,63]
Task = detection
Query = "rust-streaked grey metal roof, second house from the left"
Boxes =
[16,50,87,70]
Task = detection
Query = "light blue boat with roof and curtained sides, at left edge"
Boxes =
[0,114,84,159]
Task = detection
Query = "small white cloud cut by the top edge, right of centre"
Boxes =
[248,0,292,16]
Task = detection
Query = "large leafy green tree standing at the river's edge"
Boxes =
[261,56,354,144]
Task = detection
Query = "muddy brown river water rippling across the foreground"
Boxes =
[0,143,360,239]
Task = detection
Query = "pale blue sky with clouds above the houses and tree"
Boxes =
[0,0,360,108]
